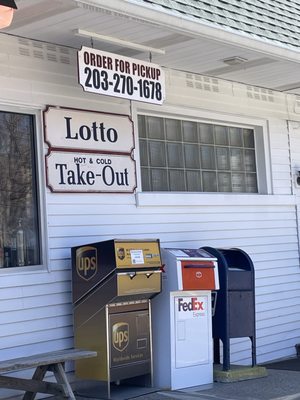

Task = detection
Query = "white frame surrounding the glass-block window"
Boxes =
[132,105,272,205]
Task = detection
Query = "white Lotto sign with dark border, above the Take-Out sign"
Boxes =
[44,107,134,153]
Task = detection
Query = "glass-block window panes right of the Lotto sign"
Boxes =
[138,115,258,193]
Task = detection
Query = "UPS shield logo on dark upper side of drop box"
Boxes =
[76,246,97,281]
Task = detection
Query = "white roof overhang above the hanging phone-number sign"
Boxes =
[0,0,300,95]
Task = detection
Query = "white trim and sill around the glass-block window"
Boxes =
[132,104,274,207]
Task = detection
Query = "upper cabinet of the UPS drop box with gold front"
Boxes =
[71,239,161,304]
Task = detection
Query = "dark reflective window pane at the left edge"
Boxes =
[0,111,40,268]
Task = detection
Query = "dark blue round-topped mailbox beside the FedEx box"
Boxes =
[203,247,256,371]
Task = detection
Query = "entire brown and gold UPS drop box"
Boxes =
[71,239,162,393]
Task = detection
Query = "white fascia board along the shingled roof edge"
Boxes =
[74,0,300,63]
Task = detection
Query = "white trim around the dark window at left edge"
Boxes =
[0,104,50,275]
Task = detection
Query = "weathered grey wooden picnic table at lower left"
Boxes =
[0,349,97,400]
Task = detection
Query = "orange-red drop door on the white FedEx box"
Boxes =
[181,259,218,290]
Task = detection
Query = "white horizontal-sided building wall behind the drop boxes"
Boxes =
[0,36,300,398]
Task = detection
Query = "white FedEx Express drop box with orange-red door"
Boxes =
[152,249,219,390]
